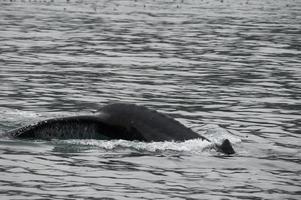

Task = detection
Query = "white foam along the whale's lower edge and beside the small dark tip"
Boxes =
[48,124,241,153]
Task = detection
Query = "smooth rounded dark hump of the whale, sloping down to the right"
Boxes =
[99,103,205,141]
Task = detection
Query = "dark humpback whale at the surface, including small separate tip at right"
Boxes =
[4,103,235,154]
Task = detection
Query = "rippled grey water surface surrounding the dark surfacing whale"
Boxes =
[0,0,301,199]
